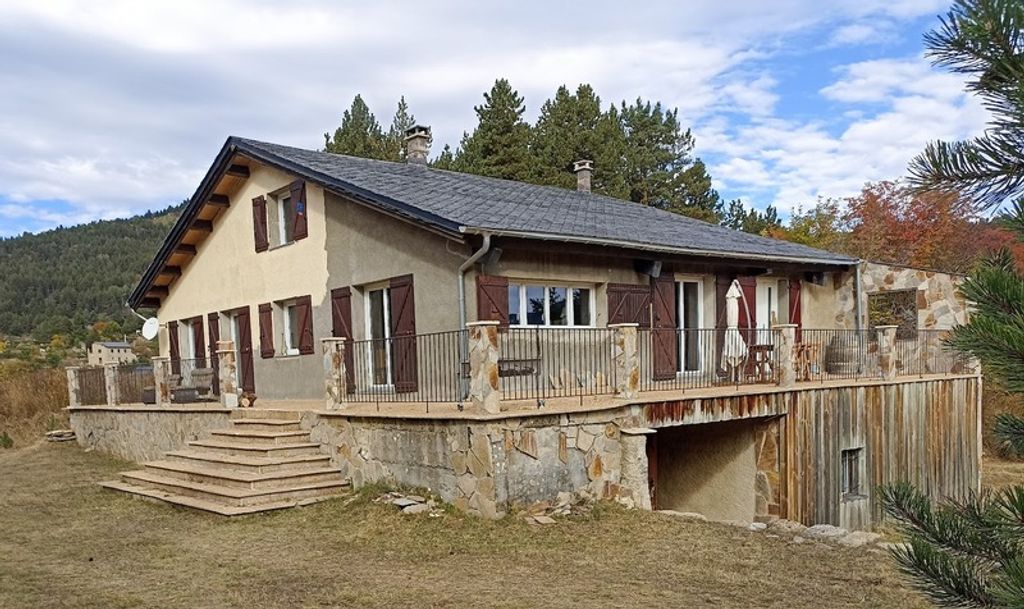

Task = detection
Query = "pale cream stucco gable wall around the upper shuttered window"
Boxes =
[158,165,331,398]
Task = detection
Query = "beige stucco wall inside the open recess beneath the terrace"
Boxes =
[657,422,757,522]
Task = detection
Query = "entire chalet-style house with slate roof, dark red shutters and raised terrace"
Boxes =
[72,128,981,528]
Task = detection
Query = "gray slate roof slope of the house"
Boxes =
[237,137,856,265]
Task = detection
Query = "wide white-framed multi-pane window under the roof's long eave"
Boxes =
[509,284,594,327]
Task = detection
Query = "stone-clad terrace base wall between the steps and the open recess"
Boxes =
[302,408,631,518]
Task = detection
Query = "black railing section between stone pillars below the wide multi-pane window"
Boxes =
[498,327,616,400]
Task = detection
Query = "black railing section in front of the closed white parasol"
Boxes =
[638,329,778,391]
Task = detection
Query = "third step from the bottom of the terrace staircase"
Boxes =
[142,460,342,490]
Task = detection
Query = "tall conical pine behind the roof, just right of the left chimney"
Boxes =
[454,79,534,181]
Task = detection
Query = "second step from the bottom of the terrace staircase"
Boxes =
[121,470,348,507]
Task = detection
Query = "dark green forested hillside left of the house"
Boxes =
[0,204,183,341]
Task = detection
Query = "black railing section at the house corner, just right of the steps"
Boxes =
[345,331,469,403]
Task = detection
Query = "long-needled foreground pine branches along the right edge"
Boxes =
[883,0,1024,607]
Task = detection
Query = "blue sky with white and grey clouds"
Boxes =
[0,0,987,236]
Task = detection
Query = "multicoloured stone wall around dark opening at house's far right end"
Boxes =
[836,262,968,330]
